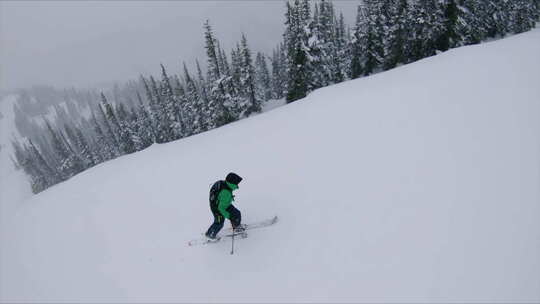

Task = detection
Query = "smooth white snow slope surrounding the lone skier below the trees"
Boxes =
[0,29,540,303]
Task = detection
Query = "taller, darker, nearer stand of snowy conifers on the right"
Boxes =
[279,0,540,102]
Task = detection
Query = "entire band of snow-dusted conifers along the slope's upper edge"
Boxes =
[12,0,539,193]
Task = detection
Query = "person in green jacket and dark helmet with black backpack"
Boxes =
[205,172,245,240]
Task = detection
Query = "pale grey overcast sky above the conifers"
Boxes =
[0,0,358,90]
